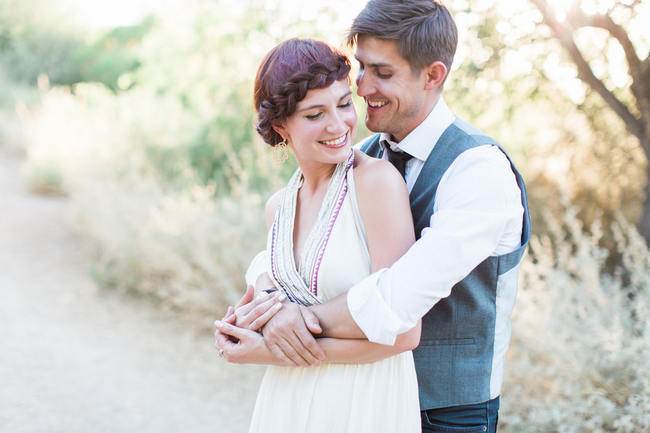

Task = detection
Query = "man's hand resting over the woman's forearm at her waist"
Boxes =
[262,302,325,367]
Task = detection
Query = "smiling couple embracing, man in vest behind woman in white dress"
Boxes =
[215,0,530,433]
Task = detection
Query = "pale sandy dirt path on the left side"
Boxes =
[0,149,262,433]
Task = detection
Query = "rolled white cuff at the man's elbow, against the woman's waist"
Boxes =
[347,269,400,346]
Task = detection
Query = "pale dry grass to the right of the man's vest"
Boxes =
[502,207,650,433]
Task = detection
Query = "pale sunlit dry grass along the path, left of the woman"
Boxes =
[21,86,265,321]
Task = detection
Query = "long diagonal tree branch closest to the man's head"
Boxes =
[530,0,645,142]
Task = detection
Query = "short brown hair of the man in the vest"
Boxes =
[347,0,458,72]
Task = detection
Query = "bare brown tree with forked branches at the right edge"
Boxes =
[530,0,650,245]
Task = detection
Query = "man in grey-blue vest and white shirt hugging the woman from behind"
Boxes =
[216,0,530,432]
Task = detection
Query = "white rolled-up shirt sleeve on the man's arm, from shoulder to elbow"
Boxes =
[347,146,523,345]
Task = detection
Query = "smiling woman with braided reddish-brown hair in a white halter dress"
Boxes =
[217,39,420,433]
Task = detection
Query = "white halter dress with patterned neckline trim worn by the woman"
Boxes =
[250,155,421,433]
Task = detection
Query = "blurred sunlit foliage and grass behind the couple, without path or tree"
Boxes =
[0,0,650,426]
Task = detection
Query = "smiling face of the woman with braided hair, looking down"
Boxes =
[278,78,357,171]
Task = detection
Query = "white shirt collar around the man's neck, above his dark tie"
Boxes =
[379,95,456,161]
